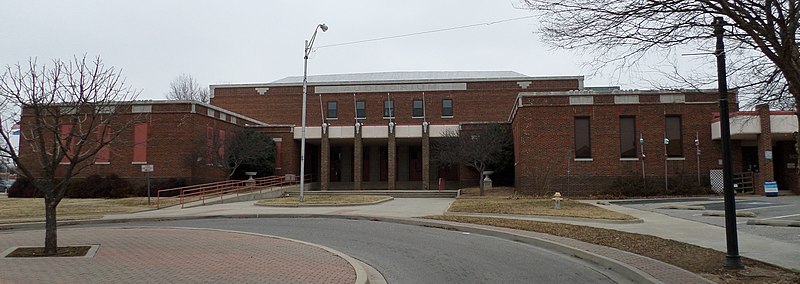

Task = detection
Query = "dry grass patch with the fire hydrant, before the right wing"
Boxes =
[448,187,636,220]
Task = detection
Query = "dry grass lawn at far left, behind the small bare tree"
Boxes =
[0,197,178,223]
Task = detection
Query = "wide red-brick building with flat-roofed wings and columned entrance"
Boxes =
[20,72,800,194]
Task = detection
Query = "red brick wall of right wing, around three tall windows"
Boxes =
[513,94,721,194]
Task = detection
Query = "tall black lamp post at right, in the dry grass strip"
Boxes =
[714,17,744,269]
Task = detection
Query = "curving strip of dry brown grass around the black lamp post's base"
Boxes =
[427,216,800,283]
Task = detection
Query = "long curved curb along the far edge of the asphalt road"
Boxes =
[0,214,688,283]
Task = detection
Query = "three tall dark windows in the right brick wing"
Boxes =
[574,115,683,159]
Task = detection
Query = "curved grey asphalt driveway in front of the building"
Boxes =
[84,218,626,283]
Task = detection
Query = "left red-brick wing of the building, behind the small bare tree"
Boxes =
[19,101,264,185]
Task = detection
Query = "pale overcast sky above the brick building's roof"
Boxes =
[0,0,692,99]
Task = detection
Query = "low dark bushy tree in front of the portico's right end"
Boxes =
[432,123,514,196]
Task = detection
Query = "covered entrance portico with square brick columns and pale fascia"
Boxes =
[295,124,458,191]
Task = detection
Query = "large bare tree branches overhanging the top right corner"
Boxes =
[523,0,800,191]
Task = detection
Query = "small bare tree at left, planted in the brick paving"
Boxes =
[0,56,138,255]
